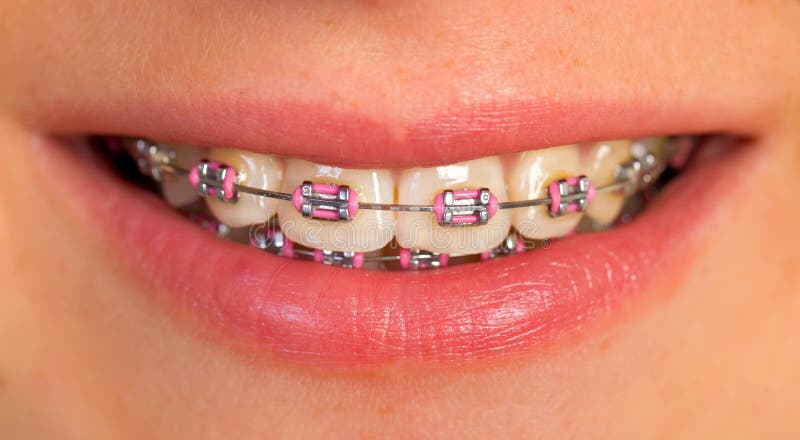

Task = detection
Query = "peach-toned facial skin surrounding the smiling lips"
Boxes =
[0,0,800,438]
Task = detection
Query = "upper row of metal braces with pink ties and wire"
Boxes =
[126,139,664,220]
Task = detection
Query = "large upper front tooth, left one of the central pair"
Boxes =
[278,159,395,252]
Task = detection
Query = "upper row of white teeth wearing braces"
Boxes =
[122,131,677,256]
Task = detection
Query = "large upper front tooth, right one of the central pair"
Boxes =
[397,156,511,254]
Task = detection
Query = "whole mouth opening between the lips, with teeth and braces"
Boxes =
[92,136,703,270]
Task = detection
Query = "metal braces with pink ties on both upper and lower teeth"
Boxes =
[114,138,667,270]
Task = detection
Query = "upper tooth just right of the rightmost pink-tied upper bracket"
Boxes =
[583,140,631,225]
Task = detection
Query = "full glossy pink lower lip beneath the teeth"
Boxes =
[36,138,731,367]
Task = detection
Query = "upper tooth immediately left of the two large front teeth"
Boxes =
[206,148,284,228]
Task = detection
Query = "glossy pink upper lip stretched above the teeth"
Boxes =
[28,95,764,168]
